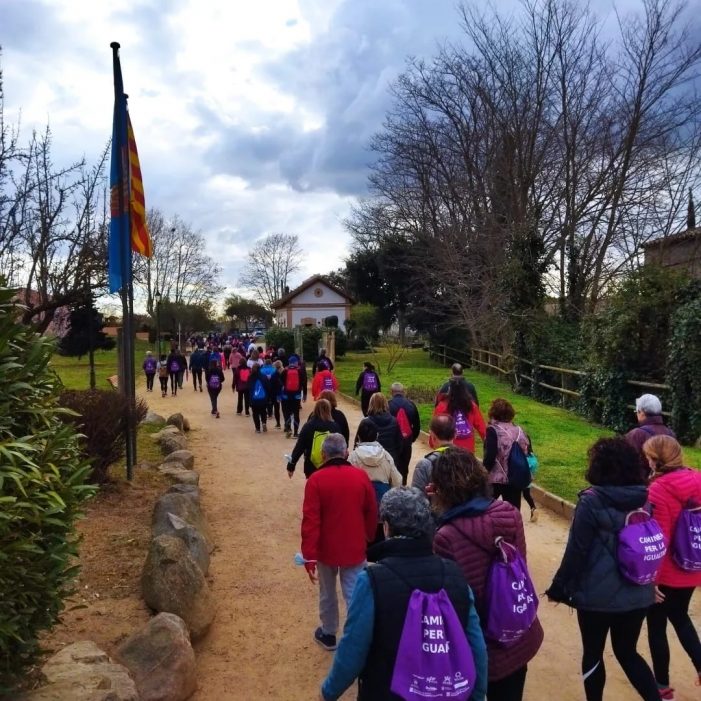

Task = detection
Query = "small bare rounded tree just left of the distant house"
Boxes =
[239,234,302,308]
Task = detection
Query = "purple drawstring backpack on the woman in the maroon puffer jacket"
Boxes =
[483,536,538,647]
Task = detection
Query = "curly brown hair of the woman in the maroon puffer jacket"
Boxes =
[431,447,489,510]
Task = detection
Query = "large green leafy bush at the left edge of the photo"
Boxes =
[0,288,94,690]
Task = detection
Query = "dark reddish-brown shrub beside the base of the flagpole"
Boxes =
[59,389,148,484]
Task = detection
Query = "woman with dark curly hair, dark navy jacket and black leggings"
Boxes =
[545,437,660,701]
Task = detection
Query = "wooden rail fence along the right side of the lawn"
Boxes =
[429,345,670,416]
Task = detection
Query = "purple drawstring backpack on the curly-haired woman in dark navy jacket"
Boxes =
[616,509,667,584]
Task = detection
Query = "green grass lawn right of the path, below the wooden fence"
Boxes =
[335,349,701,501]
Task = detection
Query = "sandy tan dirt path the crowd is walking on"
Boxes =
[142,380,701,701]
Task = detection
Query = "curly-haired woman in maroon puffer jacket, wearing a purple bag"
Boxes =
[432,446,543,701]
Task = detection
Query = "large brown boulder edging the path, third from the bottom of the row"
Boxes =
[141,535,215,640]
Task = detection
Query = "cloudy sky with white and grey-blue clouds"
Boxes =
[0,0,628,298]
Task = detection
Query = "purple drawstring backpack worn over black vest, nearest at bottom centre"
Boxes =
[383,565,477,701]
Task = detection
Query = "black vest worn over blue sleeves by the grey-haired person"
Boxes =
[358,538,470,701]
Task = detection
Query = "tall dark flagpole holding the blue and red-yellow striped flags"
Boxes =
[110,41,136,481]
